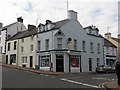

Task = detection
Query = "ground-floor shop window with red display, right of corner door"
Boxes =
[70,55,80,67]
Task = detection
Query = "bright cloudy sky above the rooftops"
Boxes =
[0,0,119,37]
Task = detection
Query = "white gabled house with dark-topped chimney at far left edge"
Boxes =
[0,17,26,54]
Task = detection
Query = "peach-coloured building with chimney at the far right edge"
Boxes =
[105,33,120,60]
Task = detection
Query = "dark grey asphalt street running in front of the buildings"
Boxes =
[2,67,116,89]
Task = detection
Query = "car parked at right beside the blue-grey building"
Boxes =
[96,65,115,73]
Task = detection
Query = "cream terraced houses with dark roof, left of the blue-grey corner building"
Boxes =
[6,25,37,68]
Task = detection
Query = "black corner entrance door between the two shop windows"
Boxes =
[56,55,64,72]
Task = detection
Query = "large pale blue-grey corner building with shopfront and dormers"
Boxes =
[37,10,103,72]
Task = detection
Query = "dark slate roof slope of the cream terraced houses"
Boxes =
[8,28,37,41]
